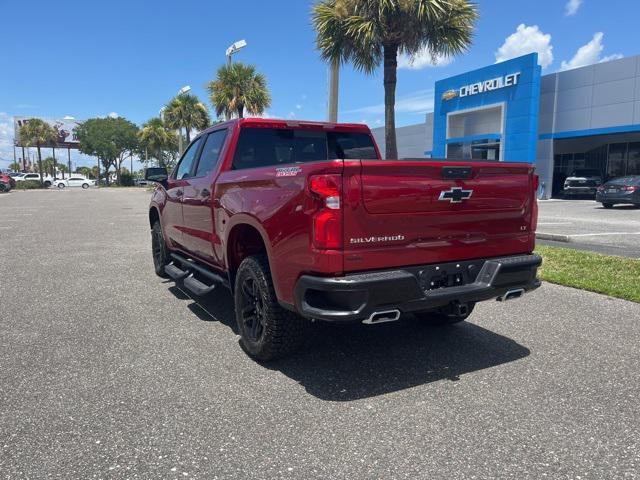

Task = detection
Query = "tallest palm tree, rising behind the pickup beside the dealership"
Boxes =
[312,0,478,158]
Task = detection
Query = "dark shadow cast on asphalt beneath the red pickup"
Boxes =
[170,287,530,402]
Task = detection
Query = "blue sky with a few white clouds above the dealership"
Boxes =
[0,0,640,168]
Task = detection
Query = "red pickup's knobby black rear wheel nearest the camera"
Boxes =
[234,255,309,361]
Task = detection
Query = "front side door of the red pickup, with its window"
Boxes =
[162,137,202,250]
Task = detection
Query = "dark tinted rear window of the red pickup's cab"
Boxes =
[233,127,377,169]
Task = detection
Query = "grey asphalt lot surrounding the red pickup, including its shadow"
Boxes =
[0,189,640,479]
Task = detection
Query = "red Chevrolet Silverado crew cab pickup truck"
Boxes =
[146,118,541,360]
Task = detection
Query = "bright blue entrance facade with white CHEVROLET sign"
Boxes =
[432,53,541,163]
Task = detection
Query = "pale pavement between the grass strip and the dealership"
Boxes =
[538,200,640,258]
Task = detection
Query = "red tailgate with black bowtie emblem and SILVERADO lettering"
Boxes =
[343,160,537,272]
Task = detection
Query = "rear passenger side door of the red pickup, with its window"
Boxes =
[182,129,227,266]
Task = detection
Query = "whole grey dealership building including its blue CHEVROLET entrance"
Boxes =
[374,53,640,198]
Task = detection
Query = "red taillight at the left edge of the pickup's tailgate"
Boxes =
[309,175,342,250]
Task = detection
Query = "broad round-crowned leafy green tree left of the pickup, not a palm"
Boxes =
[76,117,138,184]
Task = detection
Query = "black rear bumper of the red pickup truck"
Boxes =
[294,255,542,322]
